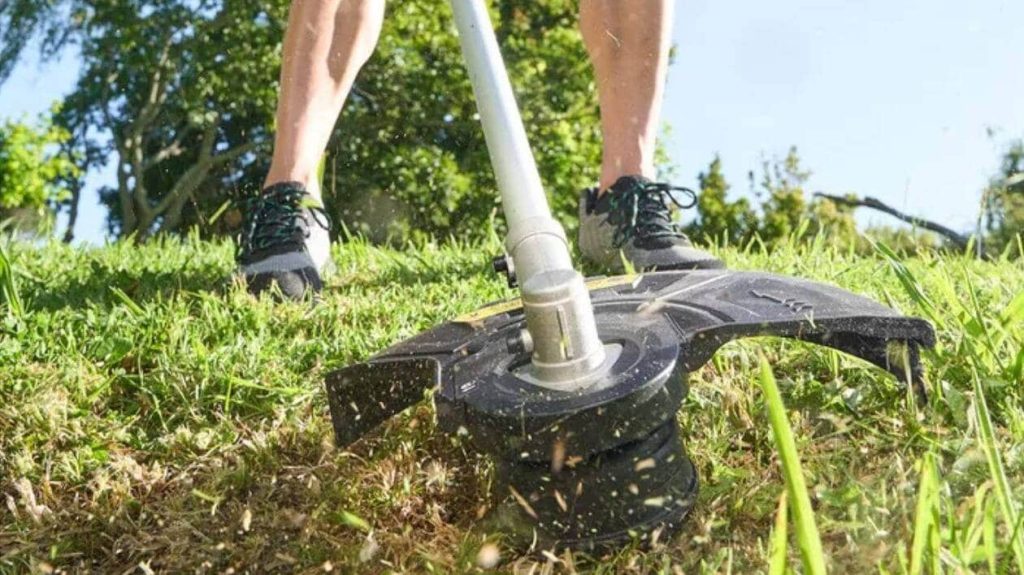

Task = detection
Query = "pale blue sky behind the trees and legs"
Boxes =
[0,0,1024,244]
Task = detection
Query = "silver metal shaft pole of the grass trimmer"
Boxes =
[452,0,605,389]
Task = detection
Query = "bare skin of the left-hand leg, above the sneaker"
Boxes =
[265,0,384,197]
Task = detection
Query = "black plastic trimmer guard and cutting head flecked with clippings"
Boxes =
[327,270,935,548]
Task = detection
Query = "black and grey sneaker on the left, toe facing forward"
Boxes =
[236,182,331,300]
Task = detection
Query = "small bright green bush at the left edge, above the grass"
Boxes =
[0,108,78,219]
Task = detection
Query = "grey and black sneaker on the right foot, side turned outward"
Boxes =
[580,176,725,273]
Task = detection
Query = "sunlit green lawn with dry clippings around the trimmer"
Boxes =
[0,234,1024,574]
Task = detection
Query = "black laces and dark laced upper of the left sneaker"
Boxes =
[236,187,331,256]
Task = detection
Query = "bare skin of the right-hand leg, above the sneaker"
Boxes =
[580,0,674,192]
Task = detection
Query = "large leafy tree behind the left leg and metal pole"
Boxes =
[0,0,600,239]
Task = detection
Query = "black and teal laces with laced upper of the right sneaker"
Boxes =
[608,182,697,248]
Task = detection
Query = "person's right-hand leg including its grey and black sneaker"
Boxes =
[580,0,723,271]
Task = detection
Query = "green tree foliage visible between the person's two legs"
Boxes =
[325,0,600,240]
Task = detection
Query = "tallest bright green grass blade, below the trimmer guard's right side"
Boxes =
[761,356,826,575]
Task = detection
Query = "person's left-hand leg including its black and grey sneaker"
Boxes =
[239,0,384,299]
